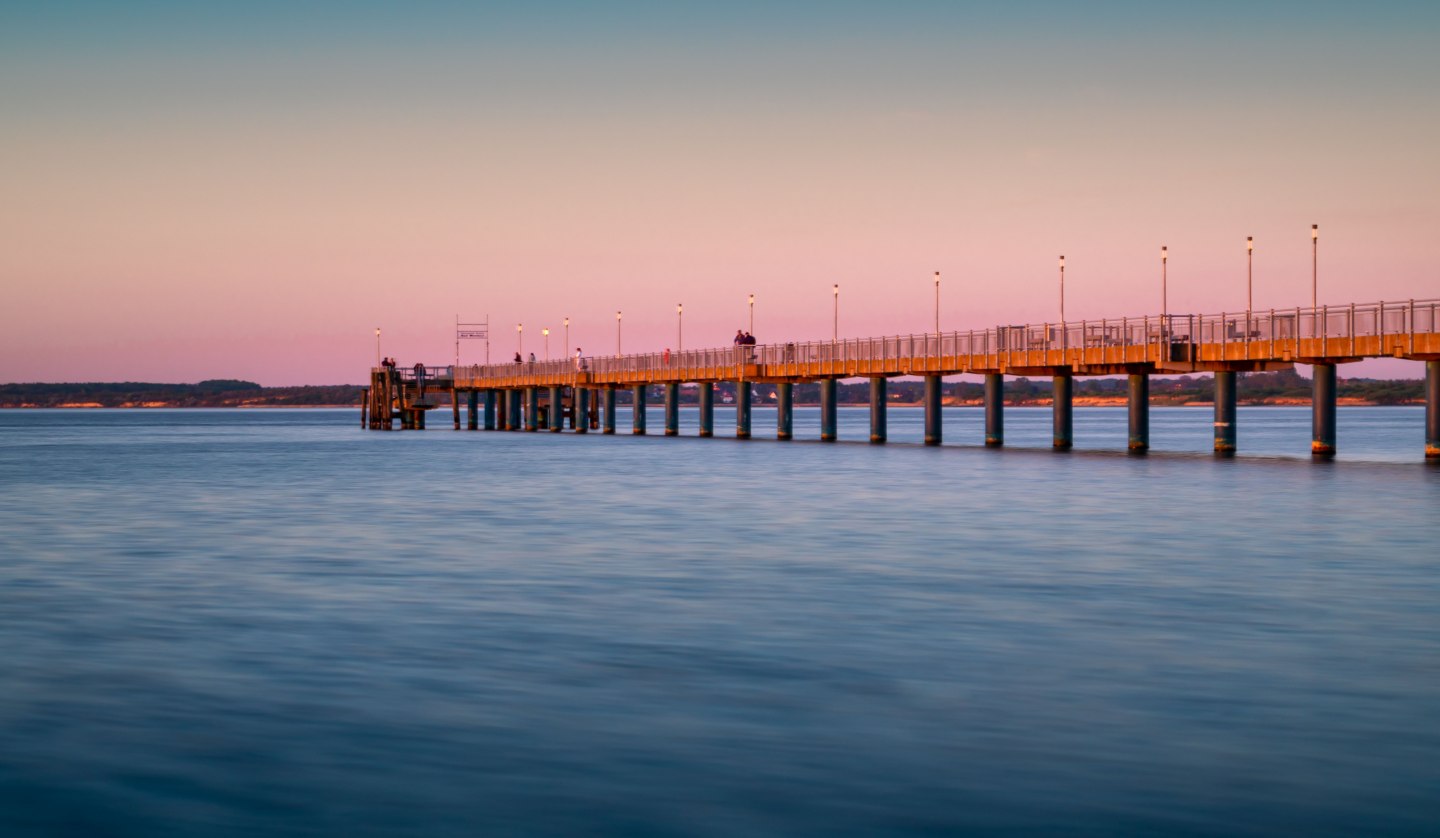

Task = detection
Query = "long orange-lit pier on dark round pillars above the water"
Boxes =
[361,299,1440,461]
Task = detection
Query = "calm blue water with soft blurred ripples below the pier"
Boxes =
[0,409,1440,837]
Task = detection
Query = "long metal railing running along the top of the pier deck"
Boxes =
[452,299,1440,382]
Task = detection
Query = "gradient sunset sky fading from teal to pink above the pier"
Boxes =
[0,0,1440,386]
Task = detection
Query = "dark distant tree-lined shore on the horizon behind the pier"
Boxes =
[0,370,1424,407]
